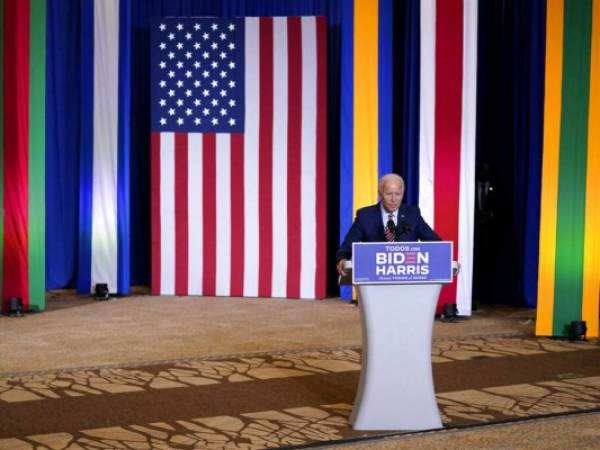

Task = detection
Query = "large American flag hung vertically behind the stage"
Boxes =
[151,17,326,298]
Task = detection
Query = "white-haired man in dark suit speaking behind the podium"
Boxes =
[336,173,441,276]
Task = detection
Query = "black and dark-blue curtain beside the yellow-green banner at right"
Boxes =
[473,0,546,307]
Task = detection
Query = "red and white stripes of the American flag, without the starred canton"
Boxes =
[152,17,326,298]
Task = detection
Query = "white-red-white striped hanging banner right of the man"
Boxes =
[419,0,477,315]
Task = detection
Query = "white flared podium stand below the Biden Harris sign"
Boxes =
[341,244,454,431]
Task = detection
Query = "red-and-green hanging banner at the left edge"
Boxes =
[0,0,46,311]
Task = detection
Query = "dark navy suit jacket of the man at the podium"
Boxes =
[336,203,441,261]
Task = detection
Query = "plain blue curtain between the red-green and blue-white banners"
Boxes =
[46,0,80,289]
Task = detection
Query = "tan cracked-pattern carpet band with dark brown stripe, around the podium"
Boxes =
[0,336,600,450]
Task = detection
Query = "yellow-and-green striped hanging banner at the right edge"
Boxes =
[536,0,600,337]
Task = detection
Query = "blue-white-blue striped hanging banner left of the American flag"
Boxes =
[77,0,131,293]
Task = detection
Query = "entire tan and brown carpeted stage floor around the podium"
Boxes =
[0,291,600,450]
